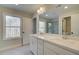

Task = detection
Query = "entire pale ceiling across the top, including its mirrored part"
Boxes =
[0,4,79,19]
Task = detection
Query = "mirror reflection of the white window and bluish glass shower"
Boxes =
[39,13,59,34]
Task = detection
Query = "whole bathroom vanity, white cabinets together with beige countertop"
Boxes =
[30,34,79,55]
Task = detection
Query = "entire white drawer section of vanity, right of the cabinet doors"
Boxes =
[44,42,74,55]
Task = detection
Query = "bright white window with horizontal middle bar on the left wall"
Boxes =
[4,16,21,39]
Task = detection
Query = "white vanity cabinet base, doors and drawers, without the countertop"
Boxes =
[30,36,75,55]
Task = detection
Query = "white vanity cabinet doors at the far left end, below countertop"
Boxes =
[30,36,44,55]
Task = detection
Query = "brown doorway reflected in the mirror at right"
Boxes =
[62,16,71,35]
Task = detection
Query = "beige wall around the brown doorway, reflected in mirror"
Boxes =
[59,10,79,35]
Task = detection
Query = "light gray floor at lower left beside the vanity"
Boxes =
[0,46,32,55]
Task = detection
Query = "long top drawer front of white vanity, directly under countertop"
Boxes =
[44,42,74,55]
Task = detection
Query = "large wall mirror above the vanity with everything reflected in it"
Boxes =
[38,5,79,36]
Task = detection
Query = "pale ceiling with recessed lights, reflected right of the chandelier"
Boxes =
[40,4,79,19]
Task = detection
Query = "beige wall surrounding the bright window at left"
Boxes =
[0,7,32,50]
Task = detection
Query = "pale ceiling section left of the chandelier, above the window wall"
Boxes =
[0,4,41,15]
